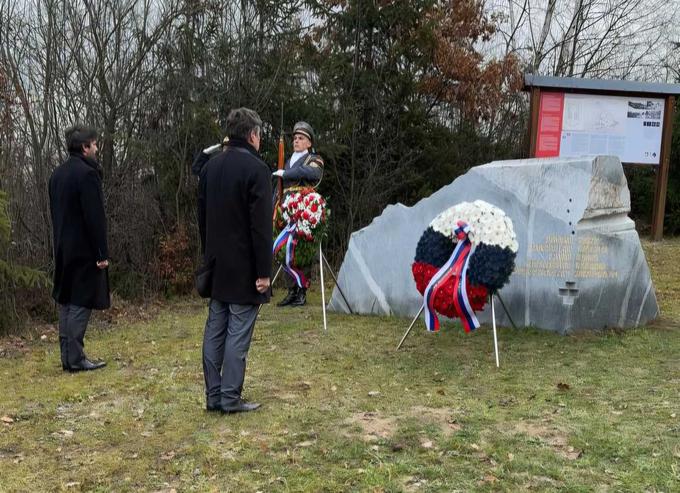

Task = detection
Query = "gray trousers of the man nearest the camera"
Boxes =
[203,300,258,407]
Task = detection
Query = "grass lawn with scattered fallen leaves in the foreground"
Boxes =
[0,240,680,493]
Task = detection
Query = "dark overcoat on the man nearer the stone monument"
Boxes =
[198,139,272,305]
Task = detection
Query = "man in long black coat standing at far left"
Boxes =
[49,126,111,372]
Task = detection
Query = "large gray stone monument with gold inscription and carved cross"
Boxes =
[329,156,659,333]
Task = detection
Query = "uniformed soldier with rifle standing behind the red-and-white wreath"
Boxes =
[273,122,323,306]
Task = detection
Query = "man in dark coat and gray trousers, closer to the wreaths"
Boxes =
[198,108,272,413]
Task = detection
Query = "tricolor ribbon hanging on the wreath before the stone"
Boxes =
[423,221,479,332]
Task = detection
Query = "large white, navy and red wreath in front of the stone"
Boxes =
[411,200,518,332]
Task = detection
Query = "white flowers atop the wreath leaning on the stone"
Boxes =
[430,200,519,253]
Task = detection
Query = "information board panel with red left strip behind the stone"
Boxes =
[536,92,664,165]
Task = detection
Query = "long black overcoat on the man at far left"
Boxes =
[49,153,111,310]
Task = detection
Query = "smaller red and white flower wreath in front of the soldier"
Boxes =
[274,188,330,268]
